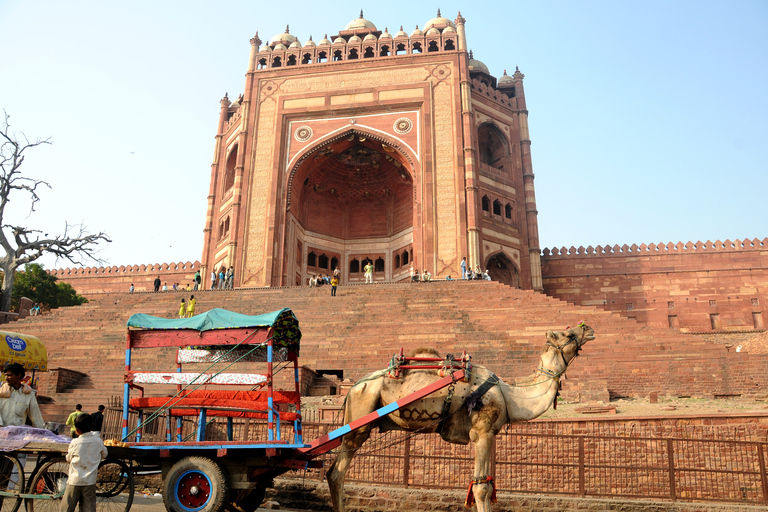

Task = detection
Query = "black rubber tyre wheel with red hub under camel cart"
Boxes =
[163,457,229,512]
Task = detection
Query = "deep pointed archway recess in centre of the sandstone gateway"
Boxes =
[283,130,416,285]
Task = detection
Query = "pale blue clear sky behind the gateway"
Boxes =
[0,0,768,268]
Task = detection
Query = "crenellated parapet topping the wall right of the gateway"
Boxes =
[542,238,768,258]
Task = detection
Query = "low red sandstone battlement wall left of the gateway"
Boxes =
[48,261,202,296]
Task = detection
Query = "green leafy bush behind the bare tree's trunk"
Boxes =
[12,263,88,309]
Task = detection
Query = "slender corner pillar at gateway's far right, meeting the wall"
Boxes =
[512,69,544,291]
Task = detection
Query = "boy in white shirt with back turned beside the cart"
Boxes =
[59,414,107,512]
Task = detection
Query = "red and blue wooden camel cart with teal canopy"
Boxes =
[117,309,470,512]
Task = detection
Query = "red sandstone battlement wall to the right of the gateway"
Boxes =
[541,238,768,332]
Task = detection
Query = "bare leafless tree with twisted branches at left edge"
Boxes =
[0,111,112,311]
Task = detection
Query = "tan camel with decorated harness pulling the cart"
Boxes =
[326,322,595,512]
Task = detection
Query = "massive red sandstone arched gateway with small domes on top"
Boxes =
[203,15,542,290]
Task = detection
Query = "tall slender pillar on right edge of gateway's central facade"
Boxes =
[456,13,480,268]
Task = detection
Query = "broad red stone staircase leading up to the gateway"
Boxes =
[8,281,768,421]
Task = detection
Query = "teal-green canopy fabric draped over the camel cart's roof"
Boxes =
[128,308,301,348]
